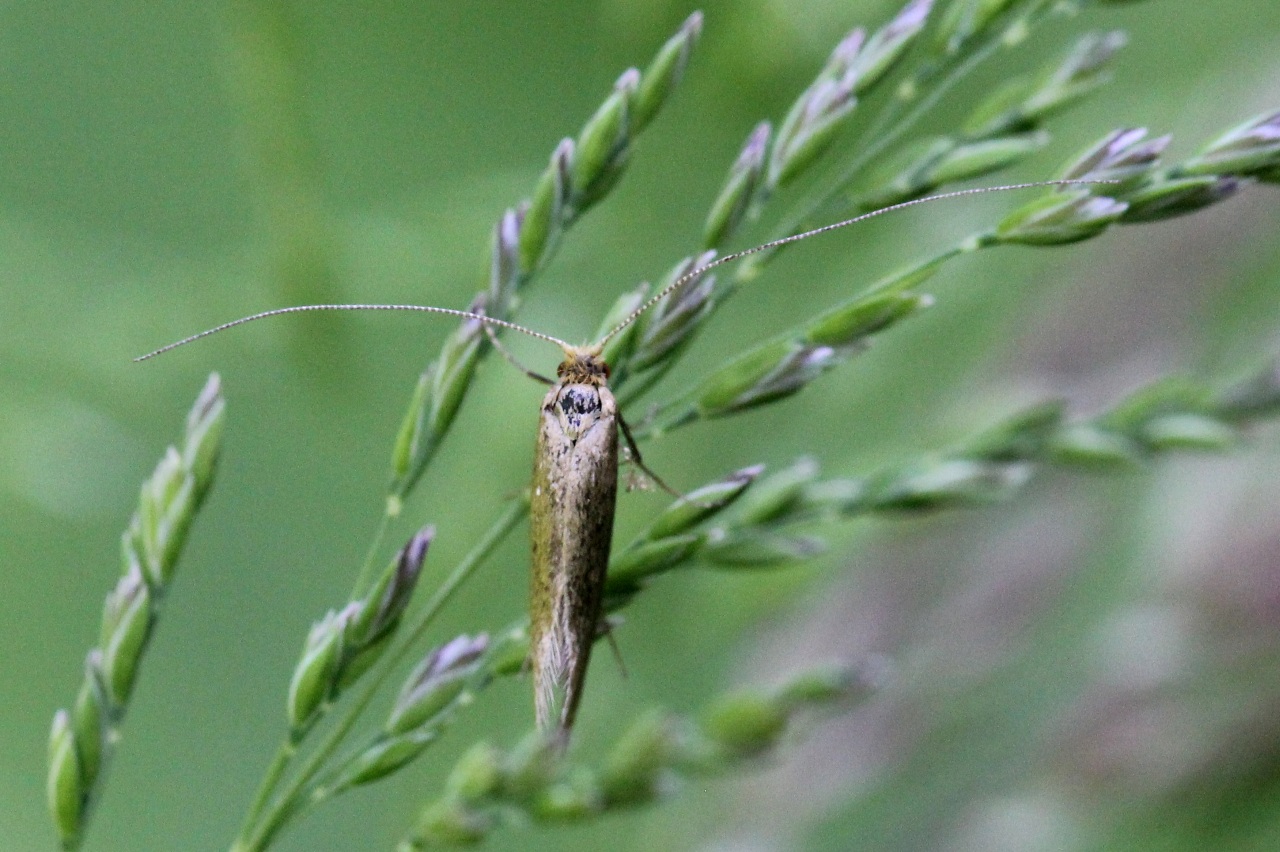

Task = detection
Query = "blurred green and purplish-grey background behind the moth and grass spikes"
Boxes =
[0,0,1280,851]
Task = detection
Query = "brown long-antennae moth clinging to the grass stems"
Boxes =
[136,180,1100,743]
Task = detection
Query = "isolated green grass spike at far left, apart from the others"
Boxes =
[47,374,227,849]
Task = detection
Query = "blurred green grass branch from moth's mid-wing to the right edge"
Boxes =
[605,362,1280,603]
